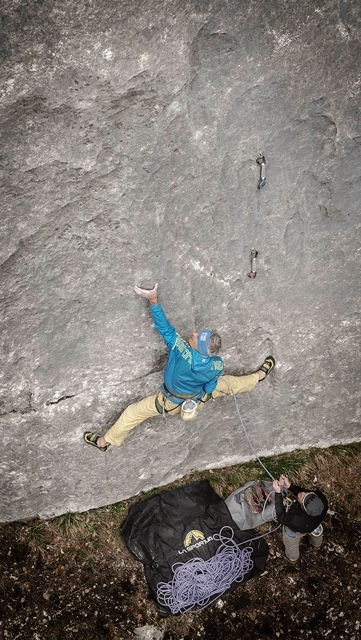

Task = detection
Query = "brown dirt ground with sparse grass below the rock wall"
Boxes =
[0,445,361,640]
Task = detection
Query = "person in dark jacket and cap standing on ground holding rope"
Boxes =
[273,475,328,562]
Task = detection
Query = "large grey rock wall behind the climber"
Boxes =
[0,0,361,521]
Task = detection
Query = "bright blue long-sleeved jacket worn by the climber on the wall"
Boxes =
[150,304,224,404]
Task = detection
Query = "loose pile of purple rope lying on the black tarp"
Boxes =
[157,527,253,614]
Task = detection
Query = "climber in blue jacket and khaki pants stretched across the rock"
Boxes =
[84,284,275,451]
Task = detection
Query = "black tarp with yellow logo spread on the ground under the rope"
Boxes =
[122,480,268,617]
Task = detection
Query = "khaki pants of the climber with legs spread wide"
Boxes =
[104,373,259,447]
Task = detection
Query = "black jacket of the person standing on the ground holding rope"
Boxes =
[275,484,328,533]
